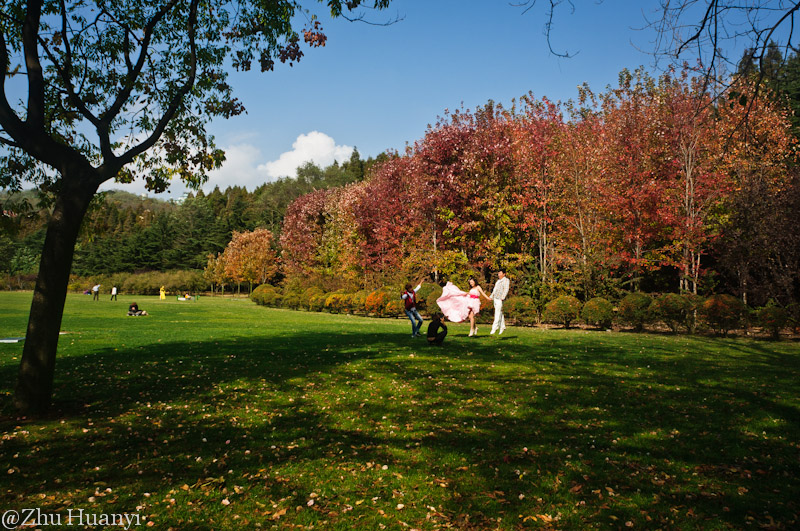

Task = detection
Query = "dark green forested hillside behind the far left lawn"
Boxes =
[0,150,389,287]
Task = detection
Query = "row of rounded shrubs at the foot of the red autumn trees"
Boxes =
[250,284,789,337]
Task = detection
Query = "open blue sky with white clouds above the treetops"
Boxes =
[104,0,668,198]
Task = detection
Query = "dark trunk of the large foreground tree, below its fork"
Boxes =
[14,179,97,414]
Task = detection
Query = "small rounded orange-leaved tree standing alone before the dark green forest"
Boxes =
[223,229,278,291]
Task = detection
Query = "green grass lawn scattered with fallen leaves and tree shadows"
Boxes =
[0,293,800,530]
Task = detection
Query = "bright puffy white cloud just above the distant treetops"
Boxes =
[258,131,353,180]
